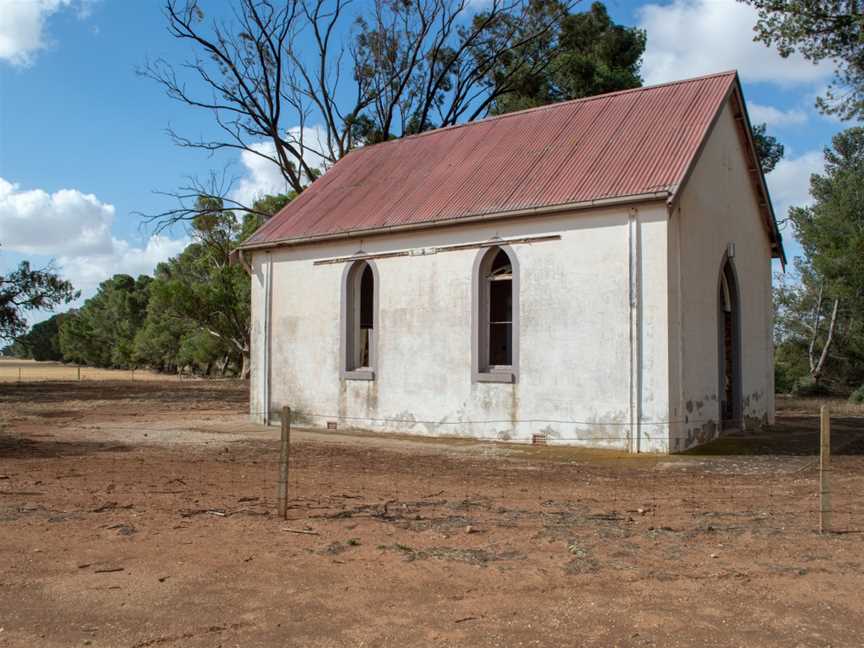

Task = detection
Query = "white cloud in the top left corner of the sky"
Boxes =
[0,0,78,66]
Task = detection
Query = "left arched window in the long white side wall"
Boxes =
[342,261,378,380]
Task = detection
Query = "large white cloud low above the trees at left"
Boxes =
[0,178,189,297]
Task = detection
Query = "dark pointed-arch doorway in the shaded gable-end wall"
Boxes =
[717,257,742,429]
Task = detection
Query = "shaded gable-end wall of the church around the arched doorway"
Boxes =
[669,100,774,451]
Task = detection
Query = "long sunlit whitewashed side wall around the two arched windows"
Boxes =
[251,203,670,452]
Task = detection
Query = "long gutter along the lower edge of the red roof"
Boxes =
[236,189,672,251]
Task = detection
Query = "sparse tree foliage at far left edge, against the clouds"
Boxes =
[0,261,80,340]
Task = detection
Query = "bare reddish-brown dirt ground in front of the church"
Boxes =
[0,382,864,648]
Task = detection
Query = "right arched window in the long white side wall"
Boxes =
[472,246,519,382]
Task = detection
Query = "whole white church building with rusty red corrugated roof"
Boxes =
[239,72,785,453]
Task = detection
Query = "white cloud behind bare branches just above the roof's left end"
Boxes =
[231,126,327,206]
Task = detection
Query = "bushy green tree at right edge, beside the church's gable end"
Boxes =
[775,128,864,390]
